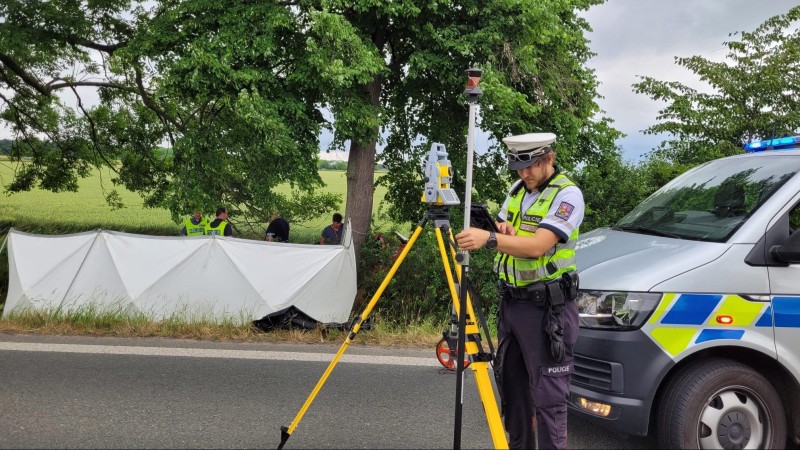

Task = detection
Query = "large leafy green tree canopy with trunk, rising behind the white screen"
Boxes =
[0,0,618,270]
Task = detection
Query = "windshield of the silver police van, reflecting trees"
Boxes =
[613,156,800,242]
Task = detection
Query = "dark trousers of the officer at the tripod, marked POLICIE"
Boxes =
[495,298,578,449]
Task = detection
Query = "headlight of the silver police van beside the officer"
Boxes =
[577,290,662,331]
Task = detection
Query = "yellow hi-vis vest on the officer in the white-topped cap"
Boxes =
[494,174,578,287]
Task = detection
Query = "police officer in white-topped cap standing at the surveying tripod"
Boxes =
[456,133,584,448]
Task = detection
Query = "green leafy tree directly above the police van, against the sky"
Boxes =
[634,7,800,168]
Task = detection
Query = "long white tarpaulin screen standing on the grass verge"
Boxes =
[4,227,356,323]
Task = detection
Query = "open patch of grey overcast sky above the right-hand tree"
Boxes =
[583,0,799,161]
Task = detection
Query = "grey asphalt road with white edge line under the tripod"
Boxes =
[0,335,656,449]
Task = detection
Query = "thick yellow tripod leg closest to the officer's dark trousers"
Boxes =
[436,227,508,449]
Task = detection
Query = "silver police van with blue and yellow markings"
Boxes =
[570,136,800,448]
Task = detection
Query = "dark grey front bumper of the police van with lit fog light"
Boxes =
[569,328,674,436]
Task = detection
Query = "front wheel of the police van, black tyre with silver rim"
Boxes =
[657,358,786,448]
